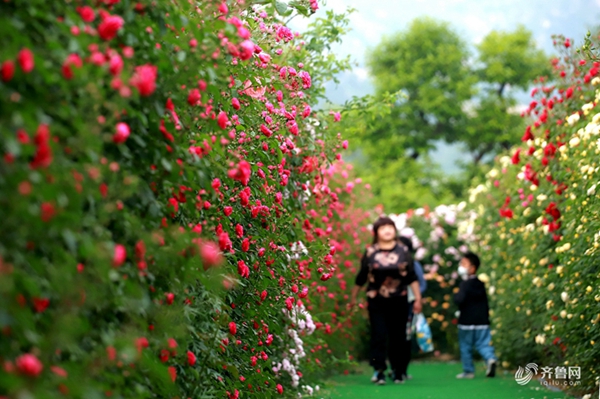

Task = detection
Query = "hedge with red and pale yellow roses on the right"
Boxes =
[471,39,600,392]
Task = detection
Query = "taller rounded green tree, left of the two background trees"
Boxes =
[365,18,475,158]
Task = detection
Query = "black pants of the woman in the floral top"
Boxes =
[368,296,408,373]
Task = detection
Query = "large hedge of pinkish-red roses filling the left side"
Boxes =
[0,0,370,398]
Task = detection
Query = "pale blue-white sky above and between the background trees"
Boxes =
[291,0,600,171]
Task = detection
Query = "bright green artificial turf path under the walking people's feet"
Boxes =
[324,362,571,399]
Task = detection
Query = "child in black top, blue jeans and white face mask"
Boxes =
[454,252,496,378]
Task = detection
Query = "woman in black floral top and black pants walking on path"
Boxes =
[350,217,421,385]
